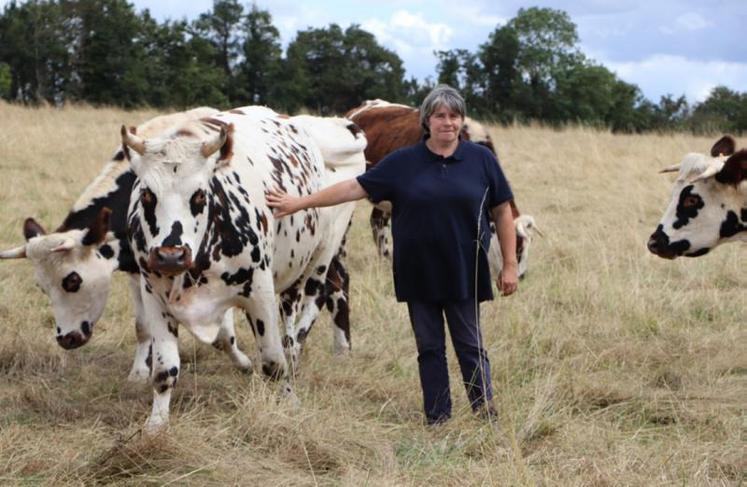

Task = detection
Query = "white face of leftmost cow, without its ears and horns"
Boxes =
[26,230,117,348]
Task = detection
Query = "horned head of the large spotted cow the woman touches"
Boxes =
[121,123,233,276]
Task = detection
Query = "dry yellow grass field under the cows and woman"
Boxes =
[0,104,747,486]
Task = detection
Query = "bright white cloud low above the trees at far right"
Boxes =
[604,54,747,102]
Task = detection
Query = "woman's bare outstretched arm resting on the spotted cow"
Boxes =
[265,178,368,218]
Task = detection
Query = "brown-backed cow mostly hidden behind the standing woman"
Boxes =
[345,99,541,277]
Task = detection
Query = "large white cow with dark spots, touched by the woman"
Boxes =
[122,107,365,429]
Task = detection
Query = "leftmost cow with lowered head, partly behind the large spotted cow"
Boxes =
[0,107,251,381]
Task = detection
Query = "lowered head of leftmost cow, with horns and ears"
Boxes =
[0,208,117,350]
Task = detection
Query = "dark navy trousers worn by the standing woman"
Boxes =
[407,299,493,424]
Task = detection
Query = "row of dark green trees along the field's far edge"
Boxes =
[0,0,747,133]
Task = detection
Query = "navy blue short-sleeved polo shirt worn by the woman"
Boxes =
[358,140,513,302]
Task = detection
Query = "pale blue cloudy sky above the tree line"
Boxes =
[0,0,747,103]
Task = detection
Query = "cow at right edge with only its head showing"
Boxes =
[648,136,747,259]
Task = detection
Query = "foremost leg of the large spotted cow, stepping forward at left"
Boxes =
[141,286,180,432]
